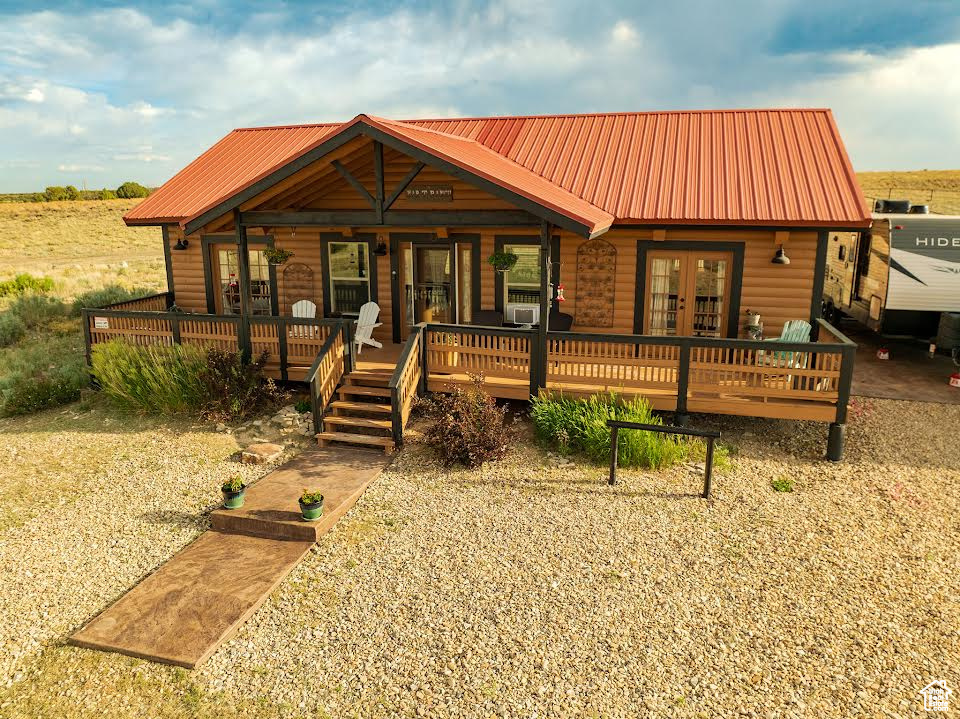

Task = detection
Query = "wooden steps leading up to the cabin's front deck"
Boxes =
[317,369,396,454]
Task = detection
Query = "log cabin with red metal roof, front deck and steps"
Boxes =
[84,109,870,460]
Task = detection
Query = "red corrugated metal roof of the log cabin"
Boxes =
[124,109,870,227]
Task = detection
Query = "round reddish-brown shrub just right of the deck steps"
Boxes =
[417,375,510,467]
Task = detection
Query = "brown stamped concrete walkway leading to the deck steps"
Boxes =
[70,447,389,669]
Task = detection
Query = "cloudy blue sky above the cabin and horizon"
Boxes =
[0,0,960,192]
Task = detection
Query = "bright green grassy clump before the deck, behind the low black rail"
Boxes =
[530,393,689,469]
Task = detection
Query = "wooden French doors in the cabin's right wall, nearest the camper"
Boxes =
[643,250,733,337]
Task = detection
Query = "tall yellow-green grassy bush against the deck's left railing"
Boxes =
[91,340,207,414]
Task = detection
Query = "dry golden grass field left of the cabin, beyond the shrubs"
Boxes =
[0,200,166,297]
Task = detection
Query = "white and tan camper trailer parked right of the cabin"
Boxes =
[824,203,960,350]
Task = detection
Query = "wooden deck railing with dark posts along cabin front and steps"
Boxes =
[84,298,856,440]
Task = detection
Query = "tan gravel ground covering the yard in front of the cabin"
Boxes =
[0,400,960,717]
